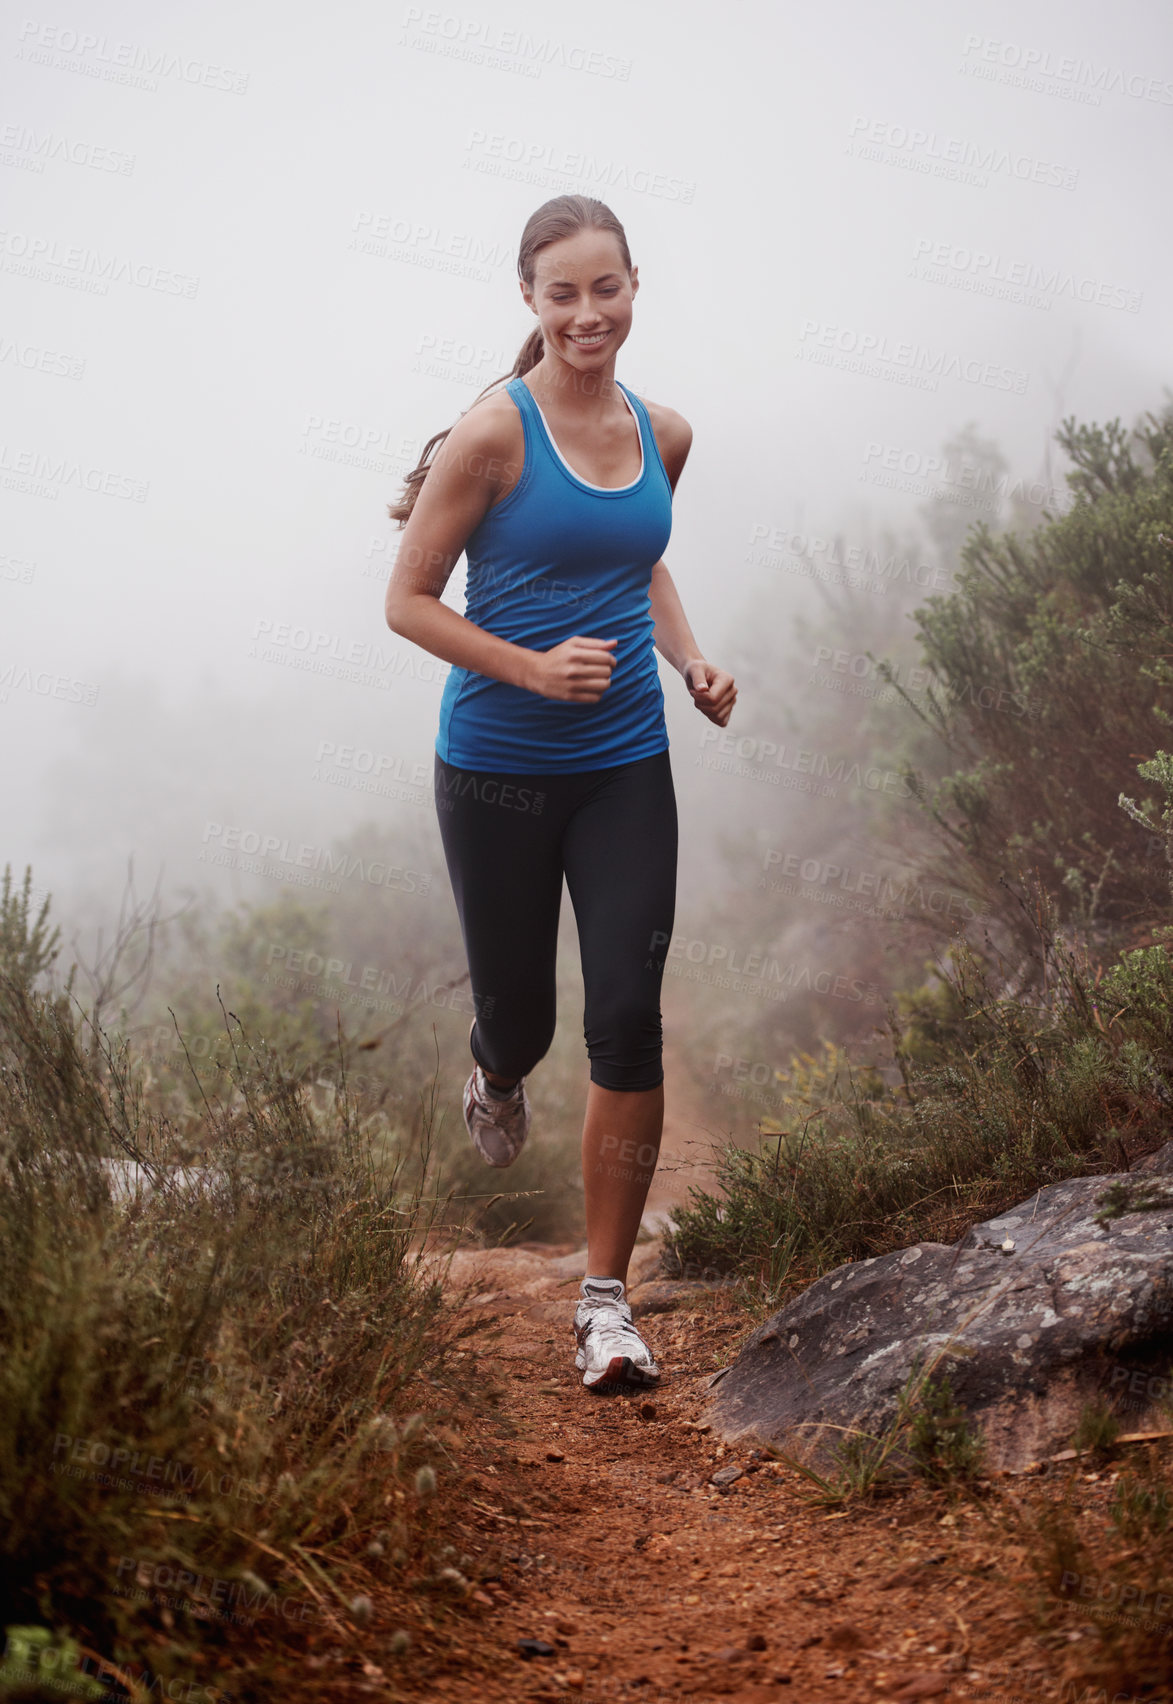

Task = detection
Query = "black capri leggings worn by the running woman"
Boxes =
[435,751,677,1089]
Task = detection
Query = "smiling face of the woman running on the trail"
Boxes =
[522,230,639,373]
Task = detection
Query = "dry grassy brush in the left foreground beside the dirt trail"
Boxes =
[0,896,480,1695]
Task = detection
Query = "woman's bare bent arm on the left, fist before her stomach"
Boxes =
[384,404,615,704]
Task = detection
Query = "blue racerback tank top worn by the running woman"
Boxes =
[436,378,672,775]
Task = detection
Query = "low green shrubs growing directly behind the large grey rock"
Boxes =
[668,896,1173,1305]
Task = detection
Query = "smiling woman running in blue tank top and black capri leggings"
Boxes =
[385,196,737,1390]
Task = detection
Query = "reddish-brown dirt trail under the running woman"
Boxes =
[394,1242,1083,1704]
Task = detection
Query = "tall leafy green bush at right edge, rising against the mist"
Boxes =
[886,407,1173,975]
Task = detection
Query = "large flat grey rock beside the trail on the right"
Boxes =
[704,1142,1173,1469]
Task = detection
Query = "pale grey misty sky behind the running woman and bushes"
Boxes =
[0,0,1173,933]
